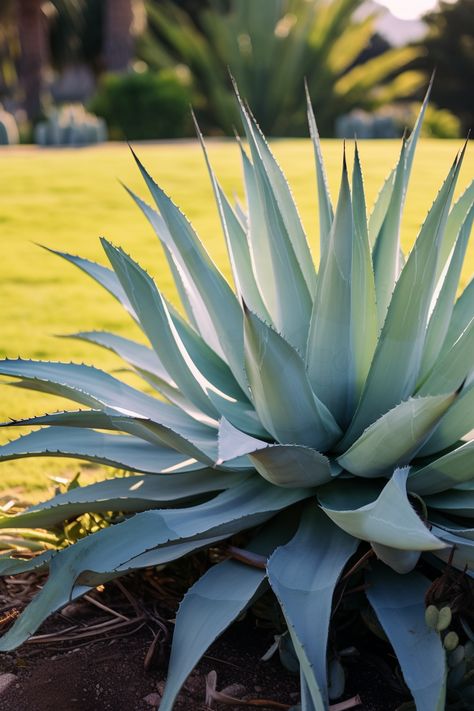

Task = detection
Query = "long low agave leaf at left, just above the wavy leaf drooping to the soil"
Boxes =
[0,469,245,528]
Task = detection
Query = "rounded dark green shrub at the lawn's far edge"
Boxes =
[91,70,191,140]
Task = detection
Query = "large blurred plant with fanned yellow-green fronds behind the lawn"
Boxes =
[139,0,423,135]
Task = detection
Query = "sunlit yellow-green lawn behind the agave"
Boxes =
[0,140,474,500]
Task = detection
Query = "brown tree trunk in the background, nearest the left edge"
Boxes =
[17,0,46,121]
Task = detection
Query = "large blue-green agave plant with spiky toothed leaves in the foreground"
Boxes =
[0,85,474,711]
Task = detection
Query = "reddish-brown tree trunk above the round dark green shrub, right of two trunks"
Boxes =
[104,0,134,72]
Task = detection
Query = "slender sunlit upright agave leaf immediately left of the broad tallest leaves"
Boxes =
[193,114,269,319]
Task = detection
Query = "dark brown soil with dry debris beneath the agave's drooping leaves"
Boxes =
[0,570,406,711]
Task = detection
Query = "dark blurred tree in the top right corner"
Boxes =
[422,0,474,132]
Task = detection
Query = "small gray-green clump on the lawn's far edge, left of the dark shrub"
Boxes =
[35,104,107,146]
